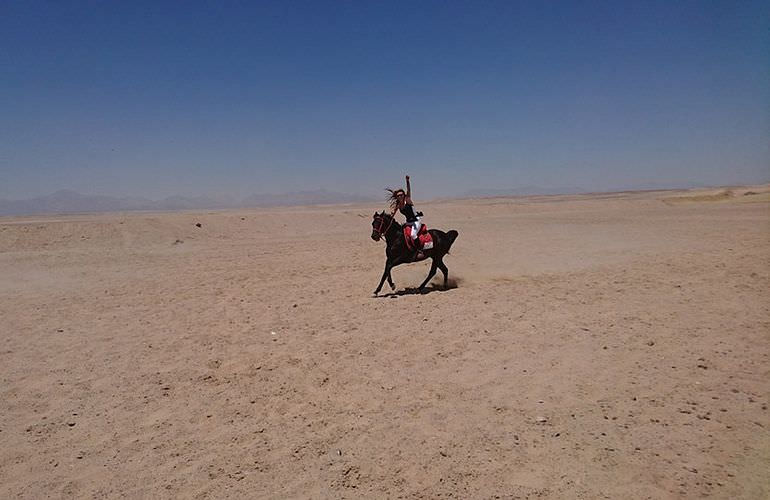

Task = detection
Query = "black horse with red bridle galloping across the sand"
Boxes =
[372,211,458,296]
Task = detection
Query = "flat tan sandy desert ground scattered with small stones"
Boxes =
[0,186,770,499]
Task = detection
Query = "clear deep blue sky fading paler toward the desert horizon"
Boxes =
[0,0,770,199]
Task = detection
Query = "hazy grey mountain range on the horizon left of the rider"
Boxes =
[0,189,374,215]
